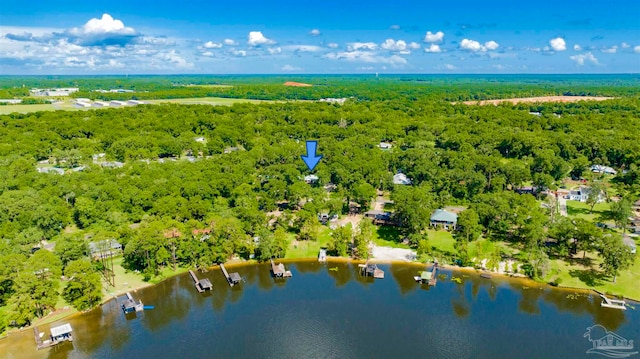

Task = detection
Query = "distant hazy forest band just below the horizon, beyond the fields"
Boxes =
[0,75,640,101]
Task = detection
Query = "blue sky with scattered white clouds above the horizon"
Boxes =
[0,0,640,75]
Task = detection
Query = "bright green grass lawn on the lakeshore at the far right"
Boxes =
[544,252,640,300]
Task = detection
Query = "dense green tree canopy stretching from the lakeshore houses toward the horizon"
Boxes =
[0,77,640,332]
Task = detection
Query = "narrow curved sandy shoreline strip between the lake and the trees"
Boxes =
[0,256,640,340]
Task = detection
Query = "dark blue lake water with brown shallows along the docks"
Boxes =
[0,262,640,359]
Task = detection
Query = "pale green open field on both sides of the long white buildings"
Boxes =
[0,97,274,115]
